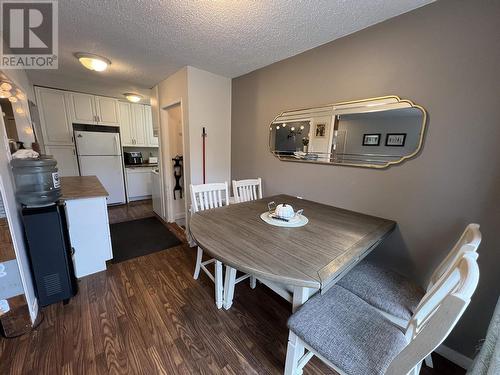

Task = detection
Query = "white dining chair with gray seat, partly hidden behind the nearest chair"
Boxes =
[338,224,481,367]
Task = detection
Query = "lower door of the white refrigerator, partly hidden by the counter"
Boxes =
[78,155,125,204]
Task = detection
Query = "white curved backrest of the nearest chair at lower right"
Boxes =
[386,251,479,375]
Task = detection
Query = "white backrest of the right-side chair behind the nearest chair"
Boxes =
[427,224,481,289]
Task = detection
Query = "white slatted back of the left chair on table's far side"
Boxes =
[190,182,229,213]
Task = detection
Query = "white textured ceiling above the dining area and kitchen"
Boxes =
[28,0,433,100]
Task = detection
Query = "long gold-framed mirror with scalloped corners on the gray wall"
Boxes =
[269,96,427,168]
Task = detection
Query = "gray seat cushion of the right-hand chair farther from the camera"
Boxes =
[338,260,425,321]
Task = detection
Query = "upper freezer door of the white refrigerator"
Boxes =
[75,130,121,156]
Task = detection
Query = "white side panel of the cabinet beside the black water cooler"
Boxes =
[66,197,113,278]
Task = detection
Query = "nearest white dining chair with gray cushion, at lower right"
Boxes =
[285,252,479,375]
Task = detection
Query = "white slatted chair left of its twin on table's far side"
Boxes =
[189,182,229,309]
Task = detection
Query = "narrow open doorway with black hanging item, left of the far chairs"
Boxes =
[160,101,187,226]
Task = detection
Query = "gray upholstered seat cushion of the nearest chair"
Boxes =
[288,285,407,375]
